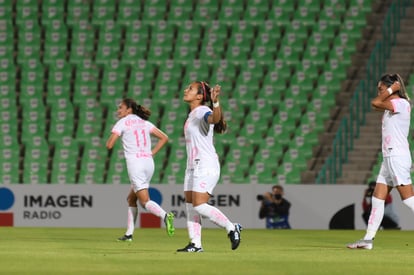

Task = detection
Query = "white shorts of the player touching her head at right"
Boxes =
[377,156,411,187]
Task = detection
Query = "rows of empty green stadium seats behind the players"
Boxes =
[0,0,384,184]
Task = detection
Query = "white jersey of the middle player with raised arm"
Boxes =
[184,106,218,169]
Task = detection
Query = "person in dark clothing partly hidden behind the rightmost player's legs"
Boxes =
[362,181,401,229]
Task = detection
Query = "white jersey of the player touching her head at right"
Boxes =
[382,98,411,157]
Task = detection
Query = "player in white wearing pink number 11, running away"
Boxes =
[106,98,175,241]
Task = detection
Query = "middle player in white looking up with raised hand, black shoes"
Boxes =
[177,81,241,252]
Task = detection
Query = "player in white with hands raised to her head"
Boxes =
[347,74,414,249]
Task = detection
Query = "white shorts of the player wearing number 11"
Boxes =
[126,157,154,193]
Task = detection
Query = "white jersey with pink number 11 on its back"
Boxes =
[112,114,155,158]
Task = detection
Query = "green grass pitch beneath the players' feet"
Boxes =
[0,227,414,275]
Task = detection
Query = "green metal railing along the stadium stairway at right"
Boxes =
[315,0,411,184]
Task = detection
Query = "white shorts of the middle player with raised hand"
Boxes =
[184,161,220,195]
